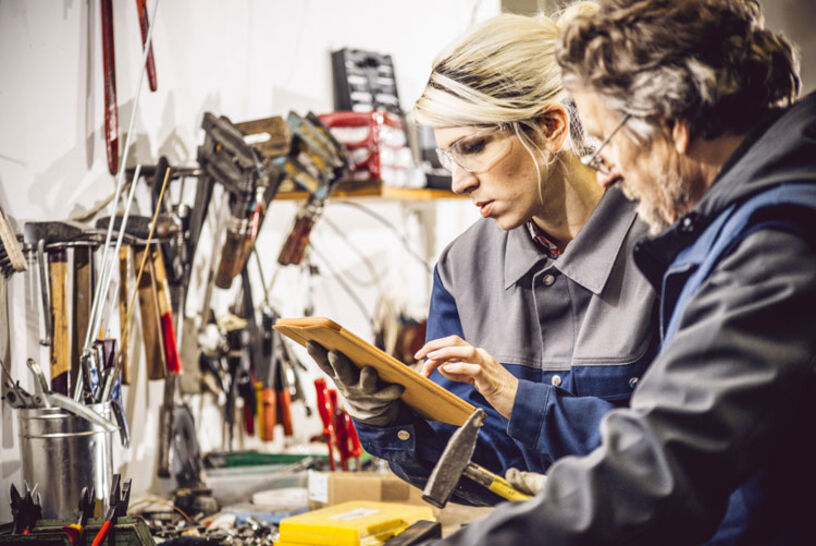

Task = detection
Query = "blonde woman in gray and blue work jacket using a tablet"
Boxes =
[311,4,657,504]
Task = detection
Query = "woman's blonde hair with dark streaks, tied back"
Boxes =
[414,2,597,162]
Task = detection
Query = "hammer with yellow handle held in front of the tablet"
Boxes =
[422,408,532,508]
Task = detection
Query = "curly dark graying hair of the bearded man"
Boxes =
[557,0,801,141]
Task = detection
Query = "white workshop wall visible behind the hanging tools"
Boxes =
[0,0,490,521]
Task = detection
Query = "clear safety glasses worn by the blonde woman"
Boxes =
[436,127,512,173]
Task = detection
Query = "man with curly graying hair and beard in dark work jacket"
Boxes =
[430,0,816,545]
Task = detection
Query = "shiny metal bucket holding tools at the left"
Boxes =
[19,403,113,519]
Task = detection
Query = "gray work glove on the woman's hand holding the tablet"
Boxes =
[306,341,405,427]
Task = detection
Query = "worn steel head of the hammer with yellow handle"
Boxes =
[422,408,487,508]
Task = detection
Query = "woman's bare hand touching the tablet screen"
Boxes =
[414,336,518,419]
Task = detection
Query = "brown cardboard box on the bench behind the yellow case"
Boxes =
[308,470,430,508]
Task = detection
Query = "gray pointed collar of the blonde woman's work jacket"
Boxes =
[504,188,636,294]
